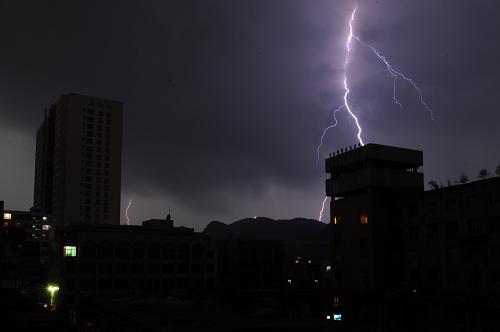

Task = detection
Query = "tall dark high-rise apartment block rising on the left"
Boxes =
[33,93,123,225]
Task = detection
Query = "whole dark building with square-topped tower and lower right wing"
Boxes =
[325,144,500,331]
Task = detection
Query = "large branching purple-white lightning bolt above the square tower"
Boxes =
[316,5,434,221]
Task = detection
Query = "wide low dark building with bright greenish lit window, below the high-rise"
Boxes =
[49,216,216,302]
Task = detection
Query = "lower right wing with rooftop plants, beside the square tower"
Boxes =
[416,177,500,296]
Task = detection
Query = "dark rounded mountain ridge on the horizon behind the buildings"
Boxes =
[203,217,329,257]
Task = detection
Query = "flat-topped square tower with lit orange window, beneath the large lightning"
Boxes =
[326,144,424,294]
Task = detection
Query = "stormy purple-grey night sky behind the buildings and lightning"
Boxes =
[0,0,500,230]
